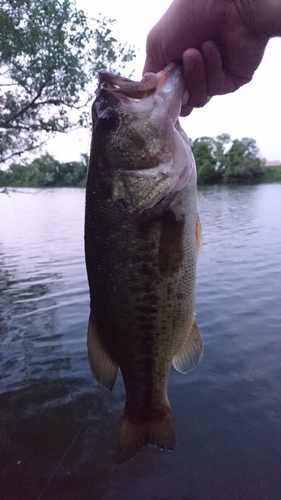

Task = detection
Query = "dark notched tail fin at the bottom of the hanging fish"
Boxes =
[117,407,176,463]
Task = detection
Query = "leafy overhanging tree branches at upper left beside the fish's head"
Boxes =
[0,0,134,164]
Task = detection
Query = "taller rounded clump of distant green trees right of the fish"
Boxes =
[192,134,263,184]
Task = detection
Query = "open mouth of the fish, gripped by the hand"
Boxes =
[99,62,181,99]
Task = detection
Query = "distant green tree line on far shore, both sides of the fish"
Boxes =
[0,134,281,187]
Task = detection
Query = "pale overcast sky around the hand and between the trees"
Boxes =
[48,0,281,161]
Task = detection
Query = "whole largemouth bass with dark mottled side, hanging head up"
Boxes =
[85,64,203,461]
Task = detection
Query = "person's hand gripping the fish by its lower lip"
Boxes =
[144,0,281,116]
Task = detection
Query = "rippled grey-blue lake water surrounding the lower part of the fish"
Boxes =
[0,184,281,500]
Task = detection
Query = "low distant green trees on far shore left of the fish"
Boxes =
[0,154,89,187]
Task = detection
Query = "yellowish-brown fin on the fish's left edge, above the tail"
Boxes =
[87,314,118,391]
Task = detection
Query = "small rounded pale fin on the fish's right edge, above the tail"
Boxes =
[173,320,203,373]
